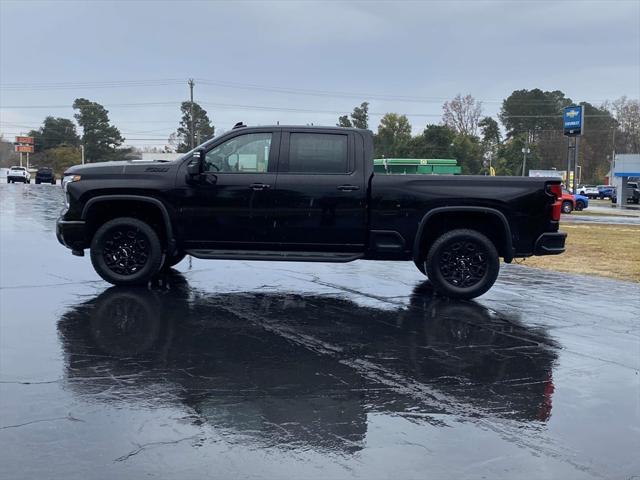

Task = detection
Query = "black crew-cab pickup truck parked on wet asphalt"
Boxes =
[56,125,566,298]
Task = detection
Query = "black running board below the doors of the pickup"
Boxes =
[186,249,364,263]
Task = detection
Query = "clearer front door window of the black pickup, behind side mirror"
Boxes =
[204,133,272,173]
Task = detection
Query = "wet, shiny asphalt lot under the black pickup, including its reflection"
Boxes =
[0,184,640,480]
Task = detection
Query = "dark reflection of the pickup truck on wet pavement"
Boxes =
[58,274,555,452]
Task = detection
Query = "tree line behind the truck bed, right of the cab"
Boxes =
[337,89,640,183]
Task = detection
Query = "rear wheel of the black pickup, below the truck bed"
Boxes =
[425,229,500,299]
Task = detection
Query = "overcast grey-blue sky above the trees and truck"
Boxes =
[0,0,640,146]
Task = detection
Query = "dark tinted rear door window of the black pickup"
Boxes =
[289,133,349,173]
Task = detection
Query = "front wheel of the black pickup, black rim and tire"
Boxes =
[91,217,162,285]
